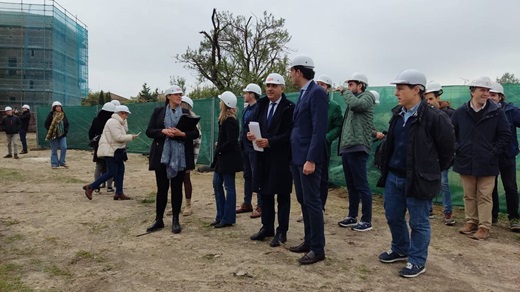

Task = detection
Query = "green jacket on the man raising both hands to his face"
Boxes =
[338,90,375,152]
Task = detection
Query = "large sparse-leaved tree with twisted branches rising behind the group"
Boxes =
[175,9,291,91]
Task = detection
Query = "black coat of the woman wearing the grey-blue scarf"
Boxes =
[146,106,199,170]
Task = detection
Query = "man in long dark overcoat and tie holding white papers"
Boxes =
[245,73,294,247]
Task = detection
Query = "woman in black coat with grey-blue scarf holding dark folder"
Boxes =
[146,85,199,233]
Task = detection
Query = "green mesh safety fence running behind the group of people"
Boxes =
[36,84,520,211]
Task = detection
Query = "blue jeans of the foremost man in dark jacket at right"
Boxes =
[383,172,431,266]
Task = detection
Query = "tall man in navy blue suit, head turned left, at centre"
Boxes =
[289,55,329,265]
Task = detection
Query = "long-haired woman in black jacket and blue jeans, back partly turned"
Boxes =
[210,91,242,228]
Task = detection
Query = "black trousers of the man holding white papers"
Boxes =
[261,194,291,234]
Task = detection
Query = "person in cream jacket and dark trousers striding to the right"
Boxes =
[83,105,137,200]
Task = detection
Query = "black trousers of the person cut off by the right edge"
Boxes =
[491,158,520,220]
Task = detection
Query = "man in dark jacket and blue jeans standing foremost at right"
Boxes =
[377,69,455,278]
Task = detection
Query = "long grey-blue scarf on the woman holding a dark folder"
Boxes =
[161,105,186,179]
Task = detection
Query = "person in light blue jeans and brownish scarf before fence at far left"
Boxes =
[45,101,69,169]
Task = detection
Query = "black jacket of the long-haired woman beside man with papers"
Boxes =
[211,117,243,174]
